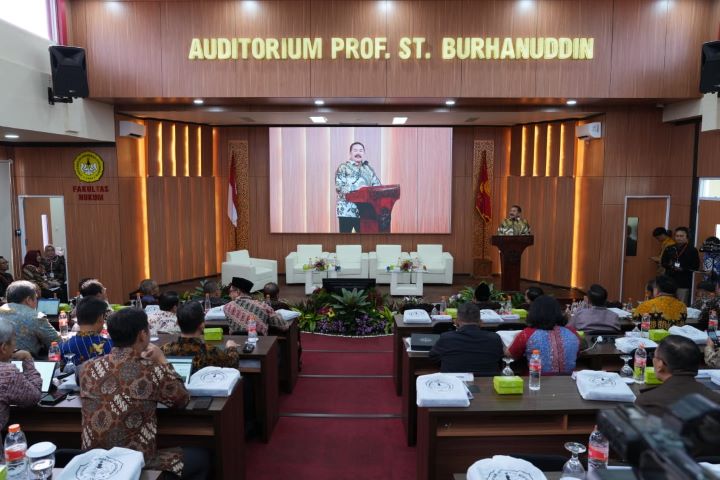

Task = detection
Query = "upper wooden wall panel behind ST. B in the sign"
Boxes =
[387,0,462,98]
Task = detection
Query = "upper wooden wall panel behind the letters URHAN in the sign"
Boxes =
[458,0,538,98]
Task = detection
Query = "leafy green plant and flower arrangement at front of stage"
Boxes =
[293,288,395,336]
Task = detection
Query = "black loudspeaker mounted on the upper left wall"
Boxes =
[48,45,89,103]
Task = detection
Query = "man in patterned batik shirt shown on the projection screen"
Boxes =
[335,142,380,233]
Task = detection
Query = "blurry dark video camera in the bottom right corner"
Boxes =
[588,394,720,480]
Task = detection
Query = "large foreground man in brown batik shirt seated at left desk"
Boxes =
[80,308,208,478]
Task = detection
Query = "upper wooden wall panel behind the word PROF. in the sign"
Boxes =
[310,0,388,98]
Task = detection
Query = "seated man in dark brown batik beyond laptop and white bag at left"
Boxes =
[162,302,240,372]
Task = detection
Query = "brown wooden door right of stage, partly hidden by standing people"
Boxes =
[622,198,669,302]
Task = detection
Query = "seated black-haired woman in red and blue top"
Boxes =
[508,295,580,375]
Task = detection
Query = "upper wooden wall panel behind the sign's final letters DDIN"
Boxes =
[535,0,613,98]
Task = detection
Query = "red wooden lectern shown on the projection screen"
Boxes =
[345,185,400,233]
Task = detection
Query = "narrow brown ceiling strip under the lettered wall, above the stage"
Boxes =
[124,107,596,125]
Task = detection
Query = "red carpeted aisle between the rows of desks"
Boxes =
[246,334,415,480]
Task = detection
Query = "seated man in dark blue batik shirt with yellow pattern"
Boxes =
[60,296,112,371]
